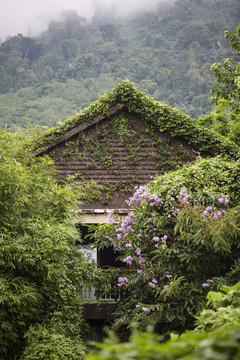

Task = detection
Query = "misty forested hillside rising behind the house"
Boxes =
[0,0,239,127]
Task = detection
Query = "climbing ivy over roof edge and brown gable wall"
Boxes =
[34,80,239,203]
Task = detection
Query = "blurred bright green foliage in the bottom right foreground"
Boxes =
[87,282,240,360]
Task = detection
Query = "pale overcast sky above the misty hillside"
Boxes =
[0,0,159,40]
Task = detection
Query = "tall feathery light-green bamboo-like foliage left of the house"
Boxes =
[0,129,99,360]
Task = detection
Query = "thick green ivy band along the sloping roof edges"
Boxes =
[36,80,239,158]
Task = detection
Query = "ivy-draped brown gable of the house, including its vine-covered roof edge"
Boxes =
[36,81,239,208]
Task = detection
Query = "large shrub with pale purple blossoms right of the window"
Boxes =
[96,158,240,332]
